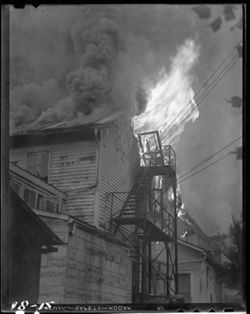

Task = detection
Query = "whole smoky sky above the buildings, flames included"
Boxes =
[10,4,242,234]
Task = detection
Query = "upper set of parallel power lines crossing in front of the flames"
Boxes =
[161,41,241,144]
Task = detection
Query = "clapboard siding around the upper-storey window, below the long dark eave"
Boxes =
[10,142,97,224]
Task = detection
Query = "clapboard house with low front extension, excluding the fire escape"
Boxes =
[10,111,139,303]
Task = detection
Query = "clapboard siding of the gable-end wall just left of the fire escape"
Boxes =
[98,122,139,228]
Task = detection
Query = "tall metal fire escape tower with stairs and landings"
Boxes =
[110,131,178,303]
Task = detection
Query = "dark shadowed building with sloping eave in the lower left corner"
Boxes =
[9,189,63,303]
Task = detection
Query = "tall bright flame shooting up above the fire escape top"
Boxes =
[132,40,199,143]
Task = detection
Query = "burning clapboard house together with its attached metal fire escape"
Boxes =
[7,113,224,303]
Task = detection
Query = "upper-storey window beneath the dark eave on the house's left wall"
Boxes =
[26,151,49,182]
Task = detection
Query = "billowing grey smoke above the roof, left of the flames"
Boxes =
[10,5,197,132]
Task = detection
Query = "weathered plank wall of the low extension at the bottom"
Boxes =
[39,215,131,304]
